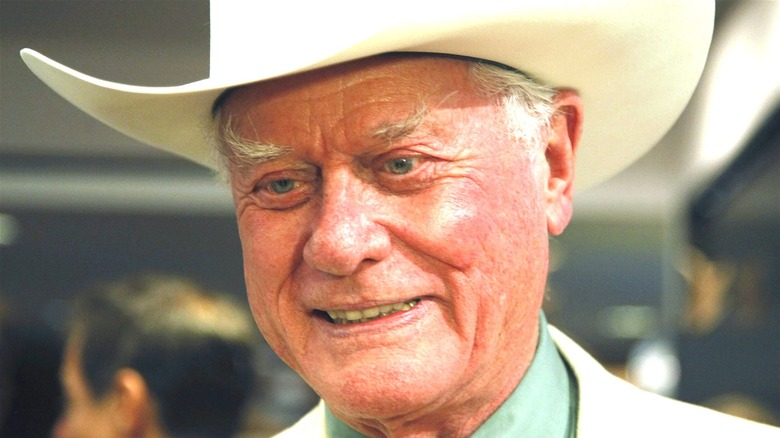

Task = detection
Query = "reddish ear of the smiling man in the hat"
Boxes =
[545,89,583,235]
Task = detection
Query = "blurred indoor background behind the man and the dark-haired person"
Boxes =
[0,0,780,437]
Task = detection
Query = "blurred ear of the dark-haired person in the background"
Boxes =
[108,368,156,436]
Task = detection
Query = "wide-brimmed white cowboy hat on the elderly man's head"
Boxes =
[21,0,714,191]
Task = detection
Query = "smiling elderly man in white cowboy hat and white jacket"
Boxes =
[23,1,777,437]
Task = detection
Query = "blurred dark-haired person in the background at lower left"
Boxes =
[52,274,274,438]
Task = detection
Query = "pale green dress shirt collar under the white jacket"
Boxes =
[325,313,578,438]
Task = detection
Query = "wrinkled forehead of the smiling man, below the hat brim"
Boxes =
[223,54,470,131]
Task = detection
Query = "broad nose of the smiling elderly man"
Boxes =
[303,172,391,276]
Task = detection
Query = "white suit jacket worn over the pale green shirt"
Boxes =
[277,326,780,438]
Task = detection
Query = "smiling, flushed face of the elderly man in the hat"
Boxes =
[223,56,560,418]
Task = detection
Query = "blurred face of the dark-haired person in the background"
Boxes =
[52,337,120,438]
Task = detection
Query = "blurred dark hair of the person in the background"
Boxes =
[70,275,257,437]
